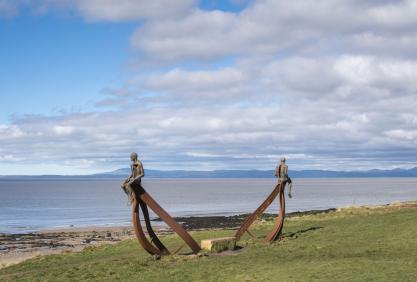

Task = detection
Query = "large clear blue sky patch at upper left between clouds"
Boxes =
[0,12,137,123]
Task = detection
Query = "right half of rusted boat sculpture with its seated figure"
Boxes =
[235,158,292,243]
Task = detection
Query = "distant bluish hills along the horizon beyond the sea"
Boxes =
[0,167,417,180]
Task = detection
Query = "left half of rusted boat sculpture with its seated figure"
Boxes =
[121,153,201,255]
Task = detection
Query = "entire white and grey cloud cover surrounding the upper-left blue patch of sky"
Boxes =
[0,0,417,174]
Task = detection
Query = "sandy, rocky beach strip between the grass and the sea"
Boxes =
[0,201,417,268]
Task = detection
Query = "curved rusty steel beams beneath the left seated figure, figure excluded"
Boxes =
[132,184,201,255]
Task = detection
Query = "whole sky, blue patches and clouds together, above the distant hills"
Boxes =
[0,0,417,175]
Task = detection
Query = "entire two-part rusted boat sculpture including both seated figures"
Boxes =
[122,153,292,255]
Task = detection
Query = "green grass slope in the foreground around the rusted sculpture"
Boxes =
[0,207,417,281]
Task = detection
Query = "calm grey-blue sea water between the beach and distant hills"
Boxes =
[0,178,417,233]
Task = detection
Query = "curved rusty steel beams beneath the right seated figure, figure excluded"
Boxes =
[235,182,286,242]
